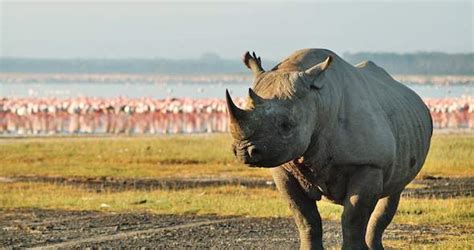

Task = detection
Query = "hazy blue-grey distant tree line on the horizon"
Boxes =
[0,52,474,75]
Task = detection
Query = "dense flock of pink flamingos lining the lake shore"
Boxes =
[0,96,474,135]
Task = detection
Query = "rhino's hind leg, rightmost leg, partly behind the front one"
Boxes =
[365,192,401,249]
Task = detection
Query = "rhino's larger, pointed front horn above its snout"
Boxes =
[225,90,250,139]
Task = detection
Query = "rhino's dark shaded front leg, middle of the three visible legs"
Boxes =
[341,167,383,249]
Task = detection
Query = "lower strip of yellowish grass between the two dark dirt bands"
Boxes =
[0,183,474,228]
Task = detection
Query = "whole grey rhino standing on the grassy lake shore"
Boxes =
[227,49,432,249]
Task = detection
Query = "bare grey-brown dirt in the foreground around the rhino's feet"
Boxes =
[0,209,469,249]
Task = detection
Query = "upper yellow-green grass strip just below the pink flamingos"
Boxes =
[0,134,474,178]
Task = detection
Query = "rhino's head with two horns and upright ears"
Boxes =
[226,52,331,167]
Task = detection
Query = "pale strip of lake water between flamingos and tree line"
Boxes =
[0,83,474,99]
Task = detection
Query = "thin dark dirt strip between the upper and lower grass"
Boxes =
[4,176,474,199]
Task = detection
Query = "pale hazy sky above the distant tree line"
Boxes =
[0,0,473,59]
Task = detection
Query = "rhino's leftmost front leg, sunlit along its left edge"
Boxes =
[271,167,323,249]
